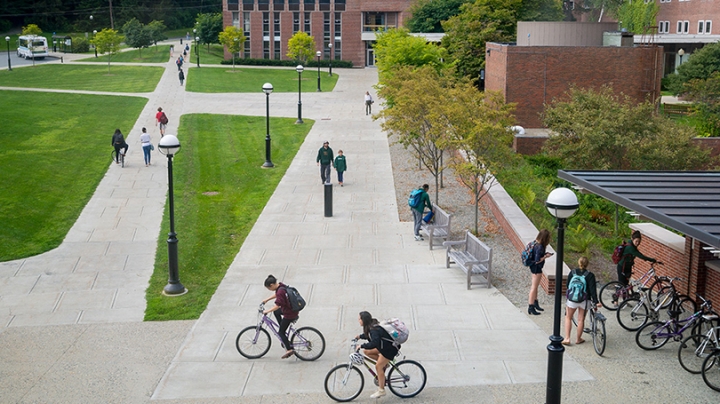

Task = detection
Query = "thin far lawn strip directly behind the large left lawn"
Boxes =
[0,64,165,92]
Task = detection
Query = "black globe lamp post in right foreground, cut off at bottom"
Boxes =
[545,188,580,404]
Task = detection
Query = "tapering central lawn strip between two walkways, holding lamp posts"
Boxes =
[145,114,313,320]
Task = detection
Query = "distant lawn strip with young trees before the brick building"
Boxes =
[186,66,338,93]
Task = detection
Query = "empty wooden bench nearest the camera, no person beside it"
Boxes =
[443,231,492,289]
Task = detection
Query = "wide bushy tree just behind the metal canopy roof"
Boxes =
[543,86,711,170]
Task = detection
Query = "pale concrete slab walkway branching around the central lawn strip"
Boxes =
[0,41,592,401]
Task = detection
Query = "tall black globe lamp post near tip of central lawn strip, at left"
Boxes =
[158,134,187,296]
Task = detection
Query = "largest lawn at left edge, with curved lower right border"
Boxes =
[0,90,147,261]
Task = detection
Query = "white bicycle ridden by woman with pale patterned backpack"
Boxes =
[325,339,427,403]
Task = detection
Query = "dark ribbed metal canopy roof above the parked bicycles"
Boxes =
[558,170,720,248]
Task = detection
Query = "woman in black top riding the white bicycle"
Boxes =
[355,311,400,398]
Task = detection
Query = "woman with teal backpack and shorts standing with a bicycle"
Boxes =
[562,257,600,345]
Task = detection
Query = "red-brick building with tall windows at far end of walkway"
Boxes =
[223,0,412,66]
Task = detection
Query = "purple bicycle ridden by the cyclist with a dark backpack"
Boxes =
[235,304,325,361]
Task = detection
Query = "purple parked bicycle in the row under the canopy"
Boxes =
[635,295,712,351]
